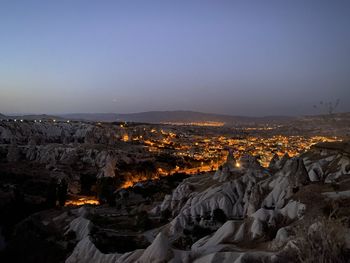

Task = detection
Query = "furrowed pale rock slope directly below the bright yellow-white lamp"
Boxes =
[159,156,270,235]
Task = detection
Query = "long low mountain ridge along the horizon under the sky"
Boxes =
[0,111,350,125]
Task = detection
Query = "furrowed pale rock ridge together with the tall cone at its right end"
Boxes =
[153,156,308,238]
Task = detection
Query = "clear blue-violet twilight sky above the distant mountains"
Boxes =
[0,0,350,116]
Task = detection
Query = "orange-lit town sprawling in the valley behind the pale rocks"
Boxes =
[115,123,341,187]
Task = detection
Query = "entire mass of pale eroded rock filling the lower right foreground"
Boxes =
[62,142,349,263]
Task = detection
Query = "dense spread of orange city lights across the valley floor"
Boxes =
[110,127,338,188]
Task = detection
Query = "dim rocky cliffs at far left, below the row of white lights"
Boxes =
[0,121,144,194]
